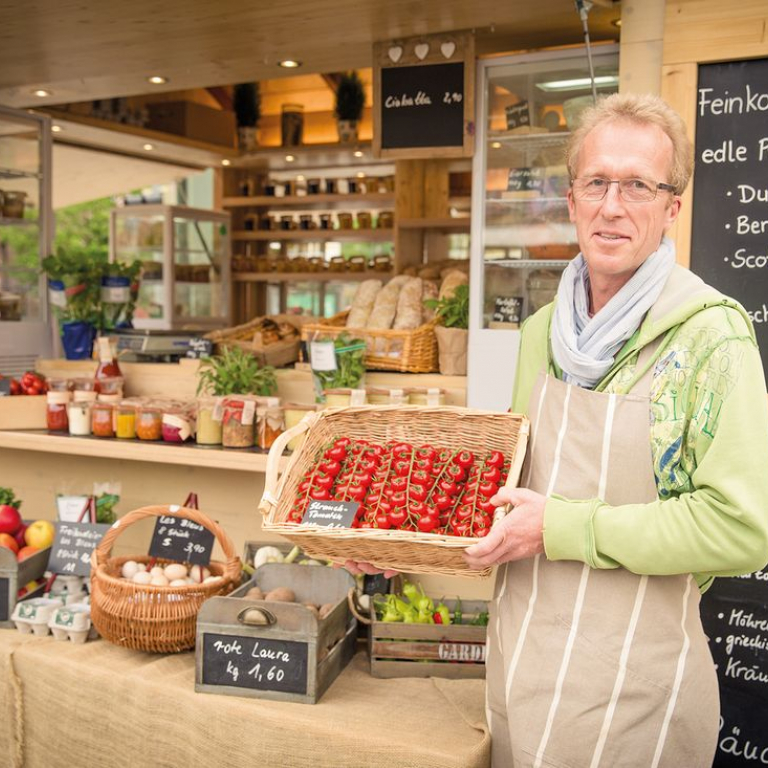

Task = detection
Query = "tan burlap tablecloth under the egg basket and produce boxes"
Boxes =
[0,630,490,768]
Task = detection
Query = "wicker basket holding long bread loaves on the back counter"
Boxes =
[301,310,438,373]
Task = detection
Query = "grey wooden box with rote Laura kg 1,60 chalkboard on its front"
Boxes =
[195,563,357,704]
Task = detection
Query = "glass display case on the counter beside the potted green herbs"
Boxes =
[110,205,230,330]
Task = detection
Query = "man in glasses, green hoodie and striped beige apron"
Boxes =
[467,95,768,768]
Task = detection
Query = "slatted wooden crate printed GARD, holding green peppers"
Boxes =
[368,595,488,678]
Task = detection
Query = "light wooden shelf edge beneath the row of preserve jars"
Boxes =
[0,430,288,472]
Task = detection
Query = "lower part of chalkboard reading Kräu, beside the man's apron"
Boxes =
[701,570,768,768]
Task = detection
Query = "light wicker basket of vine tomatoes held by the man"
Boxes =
[259,406,528,577]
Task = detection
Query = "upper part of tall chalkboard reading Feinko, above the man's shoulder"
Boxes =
[691,59,768,380]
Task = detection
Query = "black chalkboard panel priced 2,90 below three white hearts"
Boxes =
[381,62,465,149]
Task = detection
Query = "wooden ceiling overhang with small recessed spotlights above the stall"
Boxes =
[0,0,619,107]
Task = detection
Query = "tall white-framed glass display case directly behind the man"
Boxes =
[467,45,619,410]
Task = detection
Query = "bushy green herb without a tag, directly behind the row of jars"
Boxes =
[197,347,277,396]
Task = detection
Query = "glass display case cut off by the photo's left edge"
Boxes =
[0,107,53,374]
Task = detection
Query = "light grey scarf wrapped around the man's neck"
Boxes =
[551,237,675,389]
